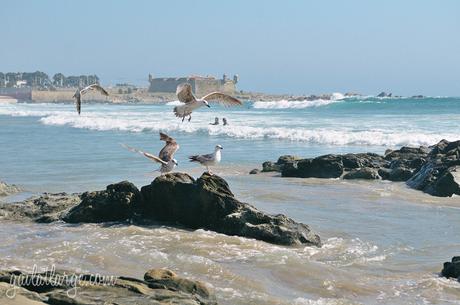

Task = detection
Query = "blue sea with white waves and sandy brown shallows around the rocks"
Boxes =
[0,94,460,304]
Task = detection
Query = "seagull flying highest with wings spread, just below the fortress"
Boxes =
[174,83,243,122]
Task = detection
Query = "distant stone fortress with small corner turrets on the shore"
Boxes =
[149,74,238,96]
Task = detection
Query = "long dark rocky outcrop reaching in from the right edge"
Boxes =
[264,140,460,196]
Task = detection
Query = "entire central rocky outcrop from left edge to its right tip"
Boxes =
[0,173,321,246]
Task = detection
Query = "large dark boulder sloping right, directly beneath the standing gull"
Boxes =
[141,173,321,245]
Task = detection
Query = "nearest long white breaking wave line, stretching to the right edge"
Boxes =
[36,114,456,146]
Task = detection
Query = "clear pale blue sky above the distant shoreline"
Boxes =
[0,0,460,96]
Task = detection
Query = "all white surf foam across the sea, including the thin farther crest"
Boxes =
[0,100,458,147]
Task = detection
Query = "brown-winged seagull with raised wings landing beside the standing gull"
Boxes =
[121,132,179,174]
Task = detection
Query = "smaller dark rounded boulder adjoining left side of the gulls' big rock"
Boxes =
[63,181,142,223]
